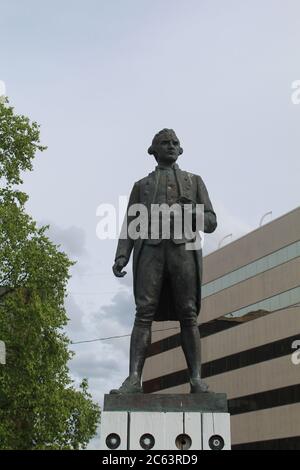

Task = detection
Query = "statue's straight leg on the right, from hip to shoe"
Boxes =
[167,241,208,393]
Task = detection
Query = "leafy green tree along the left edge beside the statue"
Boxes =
[0,102,100,450]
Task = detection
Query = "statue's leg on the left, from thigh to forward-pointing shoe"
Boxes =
[110,243,164,394]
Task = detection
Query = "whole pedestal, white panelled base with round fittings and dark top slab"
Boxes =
[100,392,231,450]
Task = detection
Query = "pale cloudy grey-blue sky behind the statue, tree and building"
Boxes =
[0,0,300,448]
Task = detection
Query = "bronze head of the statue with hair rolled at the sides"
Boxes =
[148,129,183,163]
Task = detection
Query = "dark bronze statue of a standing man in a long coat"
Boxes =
[110,129,217,394]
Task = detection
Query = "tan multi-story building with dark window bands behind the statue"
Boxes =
[144,207,300,449]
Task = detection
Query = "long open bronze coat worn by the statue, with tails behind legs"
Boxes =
[115,165,217,321]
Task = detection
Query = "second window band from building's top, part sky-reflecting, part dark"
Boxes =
[147,287,300,357]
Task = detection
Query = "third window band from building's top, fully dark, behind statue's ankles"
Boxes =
[143,332,300,393]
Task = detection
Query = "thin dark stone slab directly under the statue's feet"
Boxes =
[103,392,228,413]
